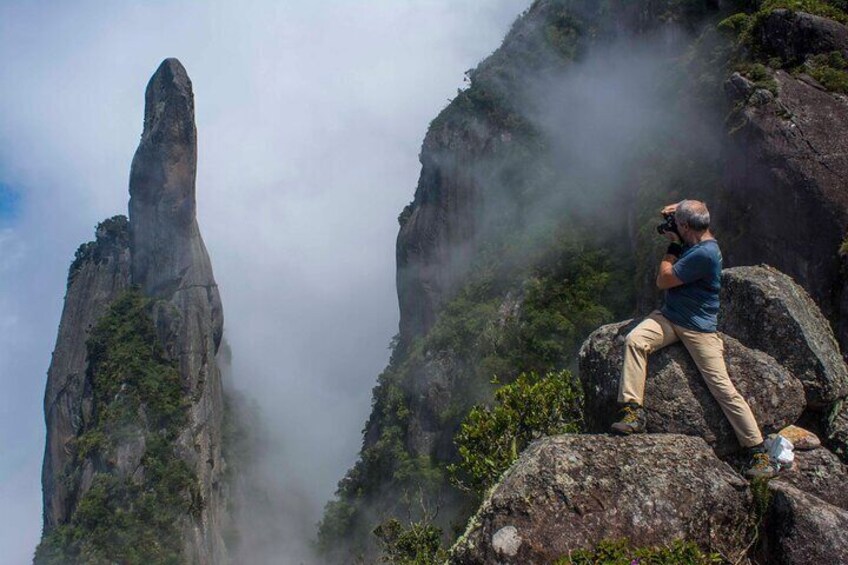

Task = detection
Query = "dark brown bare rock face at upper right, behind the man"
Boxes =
[719,10,848,350]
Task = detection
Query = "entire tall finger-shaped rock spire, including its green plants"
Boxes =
[36,59,227,563]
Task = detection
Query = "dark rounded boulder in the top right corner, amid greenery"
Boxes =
[758,10,848,65]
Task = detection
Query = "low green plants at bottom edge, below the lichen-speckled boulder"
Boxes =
[556,540,724,565]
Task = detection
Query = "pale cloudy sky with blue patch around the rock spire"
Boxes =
[0,0,530,564]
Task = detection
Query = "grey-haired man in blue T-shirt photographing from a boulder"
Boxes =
[612,200,777,478]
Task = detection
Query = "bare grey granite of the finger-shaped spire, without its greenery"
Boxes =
[42,59,227,564]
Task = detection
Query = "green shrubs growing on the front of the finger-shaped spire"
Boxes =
[35,289,197,565]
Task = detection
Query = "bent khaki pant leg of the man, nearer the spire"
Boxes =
[618,310,677,405]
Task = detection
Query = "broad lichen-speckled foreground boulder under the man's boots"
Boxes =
[450,434,750,565]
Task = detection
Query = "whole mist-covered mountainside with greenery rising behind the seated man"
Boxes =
[319,0,848,556]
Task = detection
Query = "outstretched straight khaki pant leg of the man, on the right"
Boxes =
[674,325,763,447]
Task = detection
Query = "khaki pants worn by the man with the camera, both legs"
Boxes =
[618,310,763,447]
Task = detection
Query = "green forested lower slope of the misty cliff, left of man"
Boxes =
[318,228,632,552]
